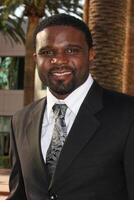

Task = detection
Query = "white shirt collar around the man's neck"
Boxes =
[47,74,93,119]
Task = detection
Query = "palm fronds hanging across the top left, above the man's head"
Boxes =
[0,0,83,43]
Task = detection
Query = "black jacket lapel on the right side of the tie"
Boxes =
[50,82,102,188]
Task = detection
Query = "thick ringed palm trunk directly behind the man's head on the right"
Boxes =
[85,0,127,91]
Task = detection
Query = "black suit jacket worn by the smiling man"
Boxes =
[8,82,134,200]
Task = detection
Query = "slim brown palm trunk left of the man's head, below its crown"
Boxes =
[24,16,39,105]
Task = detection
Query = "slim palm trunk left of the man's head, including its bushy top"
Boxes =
[24,0,46,105]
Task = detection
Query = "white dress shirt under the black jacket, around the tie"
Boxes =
[41,74,93,161]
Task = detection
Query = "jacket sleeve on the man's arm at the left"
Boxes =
[7,119,27,200]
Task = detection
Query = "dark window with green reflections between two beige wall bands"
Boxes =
[0,57,24,90]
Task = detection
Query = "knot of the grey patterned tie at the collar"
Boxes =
[53,104,67,117]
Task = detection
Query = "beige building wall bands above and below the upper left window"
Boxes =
[0,33,25,116]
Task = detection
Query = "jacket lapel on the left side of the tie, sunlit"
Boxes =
[26,100,48,180]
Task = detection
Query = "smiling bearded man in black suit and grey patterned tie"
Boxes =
[8,14,134,200]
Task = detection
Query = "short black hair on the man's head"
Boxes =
[33,13,93,48]
